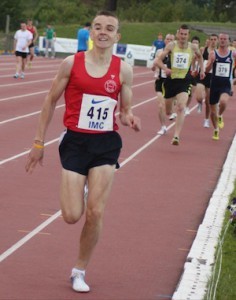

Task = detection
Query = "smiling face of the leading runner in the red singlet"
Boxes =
[90,16,120,49]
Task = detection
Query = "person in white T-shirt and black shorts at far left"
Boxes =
[14,21,33,79]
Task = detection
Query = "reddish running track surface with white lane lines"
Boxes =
[0,56,236,300]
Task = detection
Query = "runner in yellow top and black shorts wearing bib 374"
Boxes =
[156,24,205,145]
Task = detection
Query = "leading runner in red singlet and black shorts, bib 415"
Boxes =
[26,11,140,292]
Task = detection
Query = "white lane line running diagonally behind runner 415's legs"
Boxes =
[0,123,174,262]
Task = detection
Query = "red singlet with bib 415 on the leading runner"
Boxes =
[64,52,121,133]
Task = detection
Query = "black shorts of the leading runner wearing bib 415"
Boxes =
[59,130,122,176]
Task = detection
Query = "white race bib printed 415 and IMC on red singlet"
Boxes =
[78,94,117,131]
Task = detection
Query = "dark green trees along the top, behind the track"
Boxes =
[0,0,236,31]
